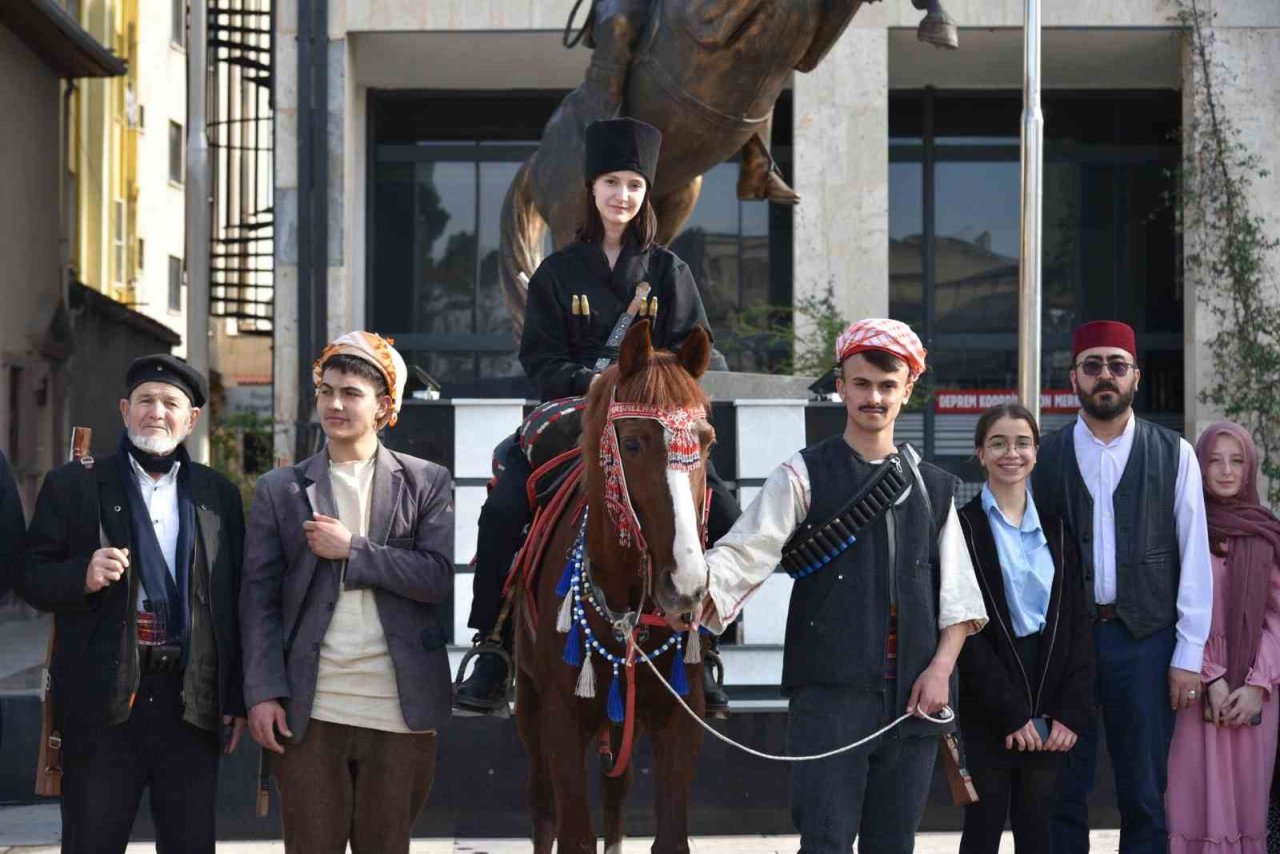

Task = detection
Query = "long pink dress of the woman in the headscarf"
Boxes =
[1165,556,1280,854]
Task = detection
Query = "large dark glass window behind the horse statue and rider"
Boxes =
[367,92,791,397]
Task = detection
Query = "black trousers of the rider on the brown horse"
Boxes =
[467,442,742,635]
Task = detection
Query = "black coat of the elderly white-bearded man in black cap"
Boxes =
[20,455,244,731]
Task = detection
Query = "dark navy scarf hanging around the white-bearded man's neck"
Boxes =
[120,431,196,643]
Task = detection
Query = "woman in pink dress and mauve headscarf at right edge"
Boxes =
[1165,421,1280,854]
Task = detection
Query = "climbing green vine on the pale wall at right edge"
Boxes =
[1178,0,1280,506]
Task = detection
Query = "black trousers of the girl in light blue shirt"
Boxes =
[960,737,1065,854]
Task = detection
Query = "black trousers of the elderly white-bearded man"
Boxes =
[61,673,219,854]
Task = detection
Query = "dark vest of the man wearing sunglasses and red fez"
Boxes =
[1033,416,1181,640]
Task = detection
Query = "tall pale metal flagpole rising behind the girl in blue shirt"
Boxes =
[1018,0,1044,421]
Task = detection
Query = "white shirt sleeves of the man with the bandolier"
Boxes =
[707,453,987,634]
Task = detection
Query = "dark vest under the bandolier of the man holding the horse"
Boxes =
[782,435,957,735]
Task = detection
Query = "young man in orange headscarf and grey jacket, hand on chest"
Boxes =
[241,332,453,854]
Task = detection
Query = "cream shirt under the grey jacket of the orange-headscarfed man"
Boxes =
[311,460,411,732]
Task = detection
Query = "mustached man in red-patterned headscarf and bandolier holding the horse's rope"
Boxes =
[680,319,987,854]
